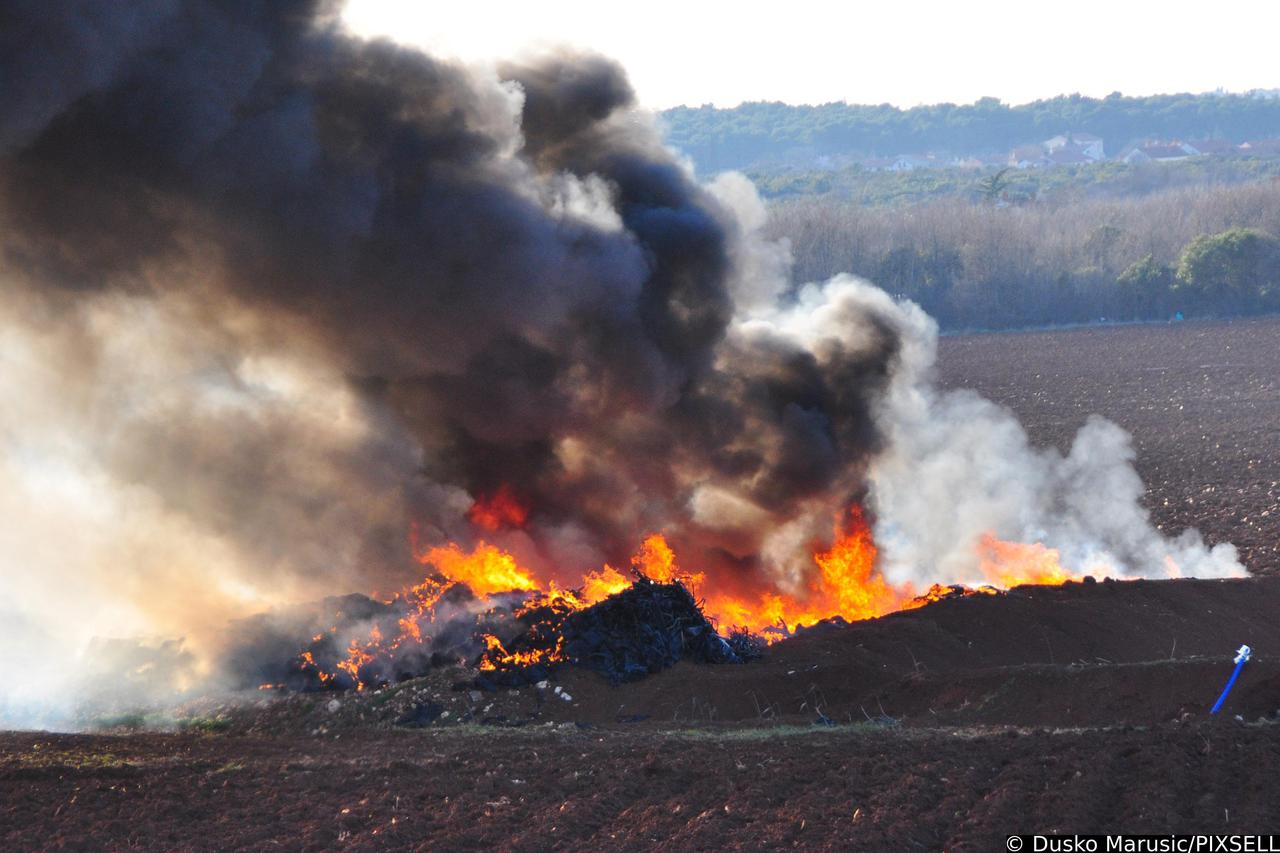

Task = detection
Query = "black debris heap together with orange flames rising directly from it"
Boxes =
[228,535,764,692]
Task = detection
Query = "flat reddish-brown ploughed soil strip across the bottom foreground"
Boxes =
[0,722,1280,850]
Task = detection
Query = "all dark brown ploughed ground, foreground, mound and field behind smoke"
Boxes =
[10,320,1280,850]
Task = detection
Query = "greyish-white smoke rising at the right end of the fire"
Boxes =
[822,277,1245,584]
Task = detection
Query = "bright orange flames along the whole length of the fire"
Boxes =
[297,491,1078,690]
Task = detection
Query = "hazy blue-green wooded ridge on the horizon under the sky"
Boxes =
[660,90,1280,172]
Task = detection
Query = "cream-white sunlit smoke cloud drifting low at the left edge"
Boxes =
[0,277,427,727]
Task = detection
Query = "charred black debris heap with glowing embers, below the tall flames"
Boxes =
[252,560,764,690]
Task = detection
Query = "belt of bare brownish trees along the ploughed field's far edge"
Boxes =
[768,181,1280,330]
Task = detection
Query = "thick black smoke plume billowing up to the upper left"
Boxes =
[0,0,897,604]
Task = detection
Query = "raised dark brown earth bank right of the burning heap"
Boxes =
[532,578,1280,725]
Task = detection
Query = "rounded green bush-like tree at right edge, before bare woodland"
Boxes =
[1172,228,1280,314]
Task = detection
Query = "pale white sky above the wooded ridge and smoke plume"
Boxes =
[347,0,1280,109]
